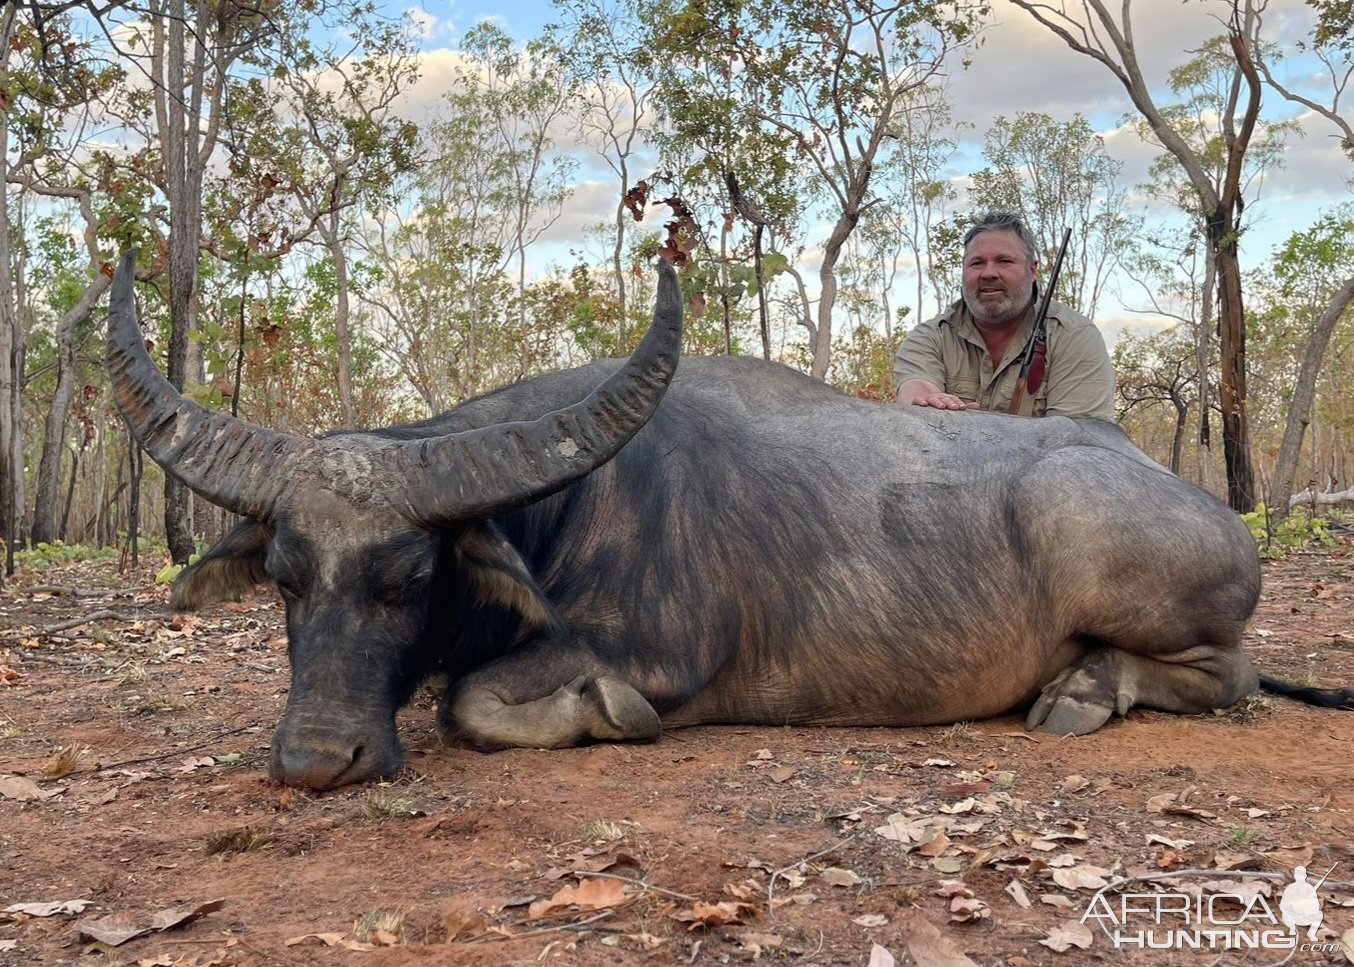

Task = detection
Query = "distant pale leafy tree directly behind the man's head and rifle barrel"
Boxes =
[968,111,1131,318]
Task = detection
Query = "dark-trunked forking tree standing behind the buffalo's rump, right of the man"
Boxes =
[1011,0,1283,511]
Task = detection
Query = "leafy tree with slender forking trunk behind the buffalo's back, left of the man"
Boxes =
[642,0,986,379]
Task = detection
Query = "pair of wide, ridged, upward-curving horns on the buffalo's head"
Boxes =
[108,251,682,525]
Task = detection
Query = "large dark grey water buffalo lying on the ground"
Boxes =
[108,245,1343,788]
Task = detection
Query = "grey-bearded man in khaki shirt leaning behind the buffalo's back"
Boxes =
[894,211,1114,420]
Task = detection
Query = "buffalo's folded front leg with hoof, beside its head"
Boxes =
[437,674,662,750]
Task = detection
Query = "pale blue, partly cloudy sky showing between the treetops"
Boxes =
[376,0,1354,335]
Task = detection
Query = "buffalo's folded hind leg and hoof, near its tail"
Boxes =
[1025,645,1257,735]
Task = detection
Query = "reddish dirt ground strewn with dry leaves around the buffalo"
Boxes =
[0,536,1354,964]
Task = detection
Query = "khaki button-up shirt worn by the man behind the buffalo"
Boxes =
[894,301,1114,420]
